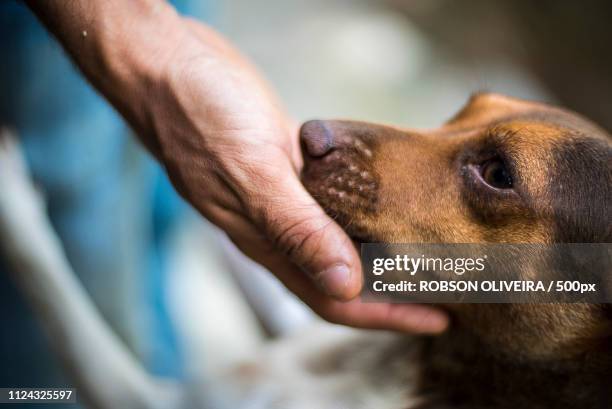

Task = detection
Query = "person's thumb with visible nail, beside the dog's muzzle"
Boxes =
[251,166,362,300]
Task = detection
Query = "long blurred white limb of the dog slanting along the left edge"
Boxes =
[0,128,183,409]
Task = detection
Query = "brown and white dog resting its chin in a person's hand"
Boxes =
[0,93,612,409]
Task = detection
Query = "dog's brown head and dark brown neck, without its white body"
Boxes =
[301,94,612,408]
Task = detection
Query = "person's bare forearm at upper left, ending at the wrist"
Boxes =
[26,0,184,153]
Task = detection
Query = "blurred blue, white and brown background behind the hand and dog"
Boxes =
[0,0,612,407]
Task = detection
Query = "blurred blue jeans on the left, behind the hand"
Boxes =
[0,0,218,407]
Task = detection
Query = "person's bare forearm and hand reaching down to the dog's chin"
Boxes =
[27,0,448,333]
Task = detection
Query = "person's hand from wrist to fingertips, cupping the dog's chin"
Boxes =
[146,20,446,332]
